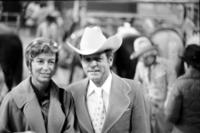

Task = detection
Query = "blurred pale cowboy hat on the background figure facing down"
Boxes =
[130,36,157,60]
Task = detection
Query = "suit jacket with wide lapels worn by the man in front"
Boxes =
[67,73,150,133]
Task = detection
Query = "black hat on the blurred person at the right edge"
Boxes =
[182,44,200,71]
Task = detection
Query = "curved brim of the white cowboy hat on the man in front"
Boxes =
[67,35,122,55]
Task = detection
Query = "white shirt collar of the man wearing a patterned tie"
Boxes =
[87,73,112,96]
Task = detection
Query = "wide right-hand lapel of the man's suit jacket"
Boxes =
[102,73,130,133]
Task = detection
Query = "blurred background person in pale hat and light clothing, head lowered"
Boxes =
[131,36,173,133]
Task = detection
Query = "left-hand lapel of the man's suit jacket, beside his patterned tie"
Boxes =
[75,79,94,133]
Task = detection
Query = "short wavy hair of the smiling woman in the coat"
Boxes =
[25,38,59,67]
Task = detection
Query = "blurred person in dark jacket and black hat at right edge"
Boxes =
[165,44,200,133]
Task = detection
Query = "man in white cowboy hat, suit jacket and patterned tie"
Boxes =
[67,26,149,133]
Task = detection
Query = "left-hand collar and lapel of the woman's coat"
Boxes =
[12,78,46,133]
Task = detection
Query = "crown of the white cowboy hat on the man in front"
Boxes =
[80,26,107,50]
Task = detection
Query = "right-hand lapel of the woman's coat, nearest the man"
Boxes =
[48,83,65,133]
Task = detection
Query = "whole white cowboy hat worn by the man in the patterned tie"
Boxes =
[67,26,122,55]
